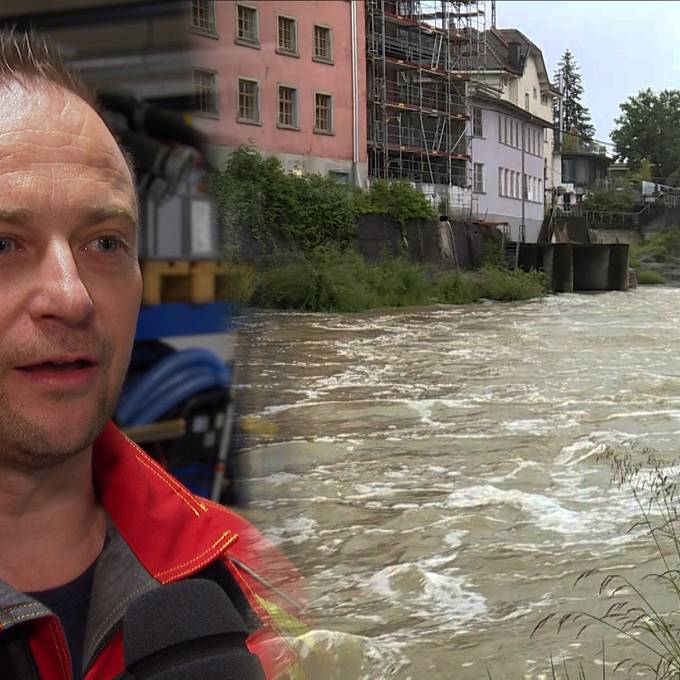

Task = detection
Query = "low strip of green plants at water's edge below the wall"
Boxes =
[253,249,547,312]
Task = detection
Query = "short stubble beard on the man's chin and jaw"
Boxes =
[0,334,124,471]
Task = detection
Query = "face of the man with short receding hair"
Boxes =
[0,81,141,468]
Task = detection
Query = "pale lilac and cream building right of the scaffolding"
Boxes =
[471,28,562,242]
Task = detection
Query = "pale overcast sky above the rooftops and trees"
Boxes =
[494,0,680,147]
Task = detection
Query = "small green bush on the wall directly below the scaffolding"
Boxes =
[355,179,434,227]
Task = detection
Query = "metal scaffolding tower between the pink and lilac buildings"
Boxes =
[366,0,485,197]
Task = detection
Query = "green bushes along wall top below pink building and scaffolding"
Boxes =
[211,147,434,261]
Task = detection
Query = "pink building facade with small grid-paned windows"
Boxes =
[192,0,367,184]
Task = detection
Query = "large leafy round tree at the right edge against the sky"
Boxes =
[611,88,680,178]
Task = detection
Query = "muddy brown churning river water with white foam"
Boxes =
[238,289,680,680]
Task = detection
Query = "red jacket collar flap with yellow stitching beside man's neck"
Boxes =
[93,422,239,583]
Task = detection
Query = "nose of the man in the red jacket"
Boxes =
[29,241,94,325]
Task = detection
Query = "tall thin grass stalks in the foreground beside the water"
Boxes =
[532,454,680,680]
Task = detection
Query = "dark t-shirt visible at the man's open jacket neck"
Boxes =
[26,558,99,678]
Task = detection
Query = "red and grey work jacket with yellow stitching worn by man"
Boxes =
[0,423,304,680]
